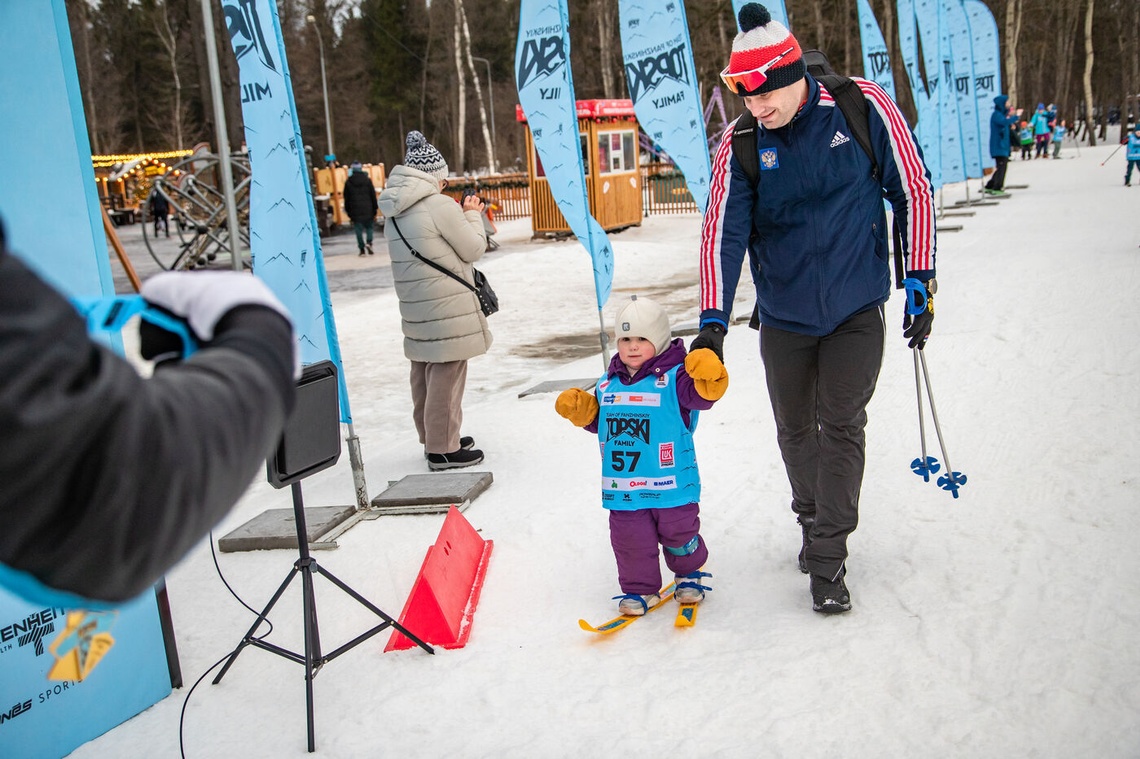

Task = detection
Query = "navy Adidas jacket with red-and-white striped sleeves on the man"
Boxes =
[700,75,935,335]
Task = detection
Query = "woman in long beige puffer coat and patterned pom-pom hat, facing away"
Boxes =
[378,131,491,471]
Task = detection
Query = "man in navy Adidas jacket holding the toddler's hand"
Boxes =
[690,3,936,613]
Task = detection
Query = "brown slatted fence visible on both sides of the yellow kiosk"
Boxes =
[443,163,698,219]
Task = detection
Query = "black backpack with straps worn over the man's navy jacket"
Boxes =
[732,45,906,316]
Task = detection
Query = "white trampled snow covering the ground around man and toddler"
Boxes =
[66,144,1140,759]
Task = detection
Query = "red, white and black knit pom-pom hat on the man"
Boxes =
[722,2,807,96]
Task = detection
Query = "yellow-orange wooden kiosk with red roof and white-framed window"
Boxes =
[515,100,642,237]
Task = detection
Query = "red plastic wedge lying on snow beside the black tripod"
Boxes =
[384,506,495,652]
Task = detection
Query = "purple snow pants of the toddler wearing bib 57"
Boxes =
[610,504,709,596]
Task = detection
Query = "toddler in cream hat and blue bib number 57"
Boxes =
[554,295,728,617]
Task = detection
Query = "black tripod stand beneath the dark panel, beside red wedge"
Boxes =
[213,482,435,753]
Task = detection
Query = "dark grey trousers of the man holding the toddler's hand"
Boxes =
[760,307,885,579]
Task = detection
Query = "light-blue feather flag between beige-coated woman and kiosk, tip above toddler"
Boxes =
[514,0,613,310]
